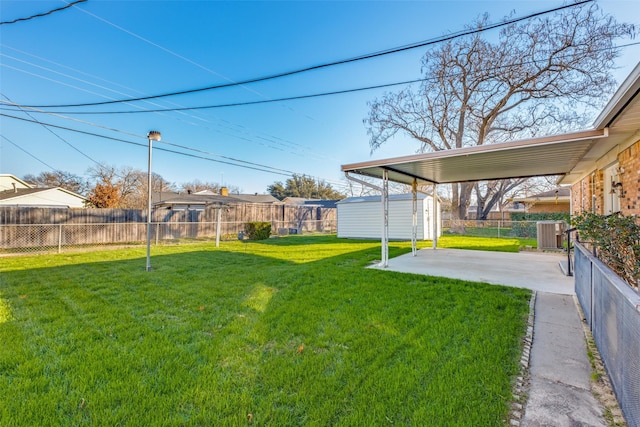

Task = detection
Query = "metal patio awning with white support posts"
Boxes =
[342,128,608,267]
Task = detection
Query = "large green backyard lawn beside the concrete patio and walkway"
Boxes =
[0,236,530,426]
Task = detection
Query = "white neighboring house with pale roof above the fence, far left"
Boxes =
[0,174,87,208]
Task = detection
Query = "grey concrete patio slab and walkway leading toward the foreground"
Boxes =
[373,249,607,427]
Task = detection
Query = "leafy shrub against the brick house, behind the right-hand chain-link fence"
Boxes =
[573,213,640,289]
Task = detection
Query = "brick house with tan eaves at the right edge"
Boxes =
[559,63,640,215]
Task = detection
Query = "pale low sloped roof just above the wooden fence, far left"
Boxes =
[0,187,87,208]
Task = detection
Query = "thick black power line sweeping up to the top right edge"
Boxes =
[17,0,595,108]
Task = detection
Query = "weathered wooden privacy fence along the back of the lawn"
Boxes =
[0,203,336,251]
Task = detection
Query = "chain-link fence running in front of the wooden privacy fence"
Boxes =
[0,219,336,255]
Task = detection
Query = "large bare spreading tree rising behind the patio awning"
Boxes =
[364,4,635,219]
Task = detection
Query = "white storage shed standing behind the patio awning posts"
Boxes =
[336,193,441,240]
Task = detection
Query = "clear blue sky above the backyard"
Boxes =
[0,0,640,193]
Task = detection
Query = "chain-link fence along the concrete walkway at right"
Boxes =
[575,243,640,427]
